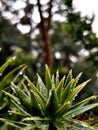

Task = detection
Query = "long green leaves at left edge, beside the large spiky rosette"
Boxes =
[0,57,26,130]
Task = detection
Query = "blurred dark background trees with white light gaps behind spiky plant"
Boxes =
[0,0,98,102]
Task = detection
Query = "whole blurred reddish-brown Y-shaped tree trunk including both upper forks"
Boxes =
[37,0,53,67]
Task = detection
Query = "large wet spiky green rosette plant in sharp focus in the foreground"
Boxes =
[0,65,98,130]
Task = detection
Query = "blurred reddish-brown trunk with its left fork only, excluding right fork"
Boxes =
[38,0,53,67]
